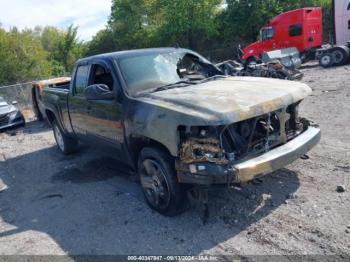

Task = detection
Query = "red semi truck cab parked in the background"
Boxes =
[242,7,323,64]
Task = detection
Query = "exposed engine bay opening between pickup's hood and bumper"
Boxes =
[179,103,309,164]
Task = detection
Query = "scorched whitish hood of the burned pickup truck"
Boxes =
[139,77,311,125]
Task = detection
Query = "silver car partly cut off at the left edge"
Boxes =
[0,96,25,131]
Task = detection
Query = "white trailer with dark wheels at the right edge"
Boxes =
[316,0,350,67]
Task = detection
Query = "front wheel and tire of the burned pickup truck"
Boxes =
[138,147,186,216]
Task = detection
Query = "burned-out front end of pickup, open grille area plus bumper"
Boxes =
[176,102,321,185]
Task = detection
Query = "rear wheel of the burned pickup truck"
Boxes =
[52,119,78,155]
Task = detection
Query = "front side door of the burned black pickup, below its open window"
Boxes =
[68,61,124,149]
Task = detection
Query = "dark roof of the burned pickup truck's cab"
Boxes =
[77,47,193,63]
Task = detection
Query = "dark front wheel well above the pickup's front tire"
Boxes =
[129,137,172,166]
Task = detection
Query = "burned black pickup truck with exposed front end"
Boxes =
[42,48,320,215]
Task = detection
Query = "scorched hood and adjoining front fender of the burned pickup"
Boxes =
[135,77,311,156]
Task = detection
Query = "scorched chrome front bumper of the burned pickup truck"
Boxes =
[176,126,321,185]
